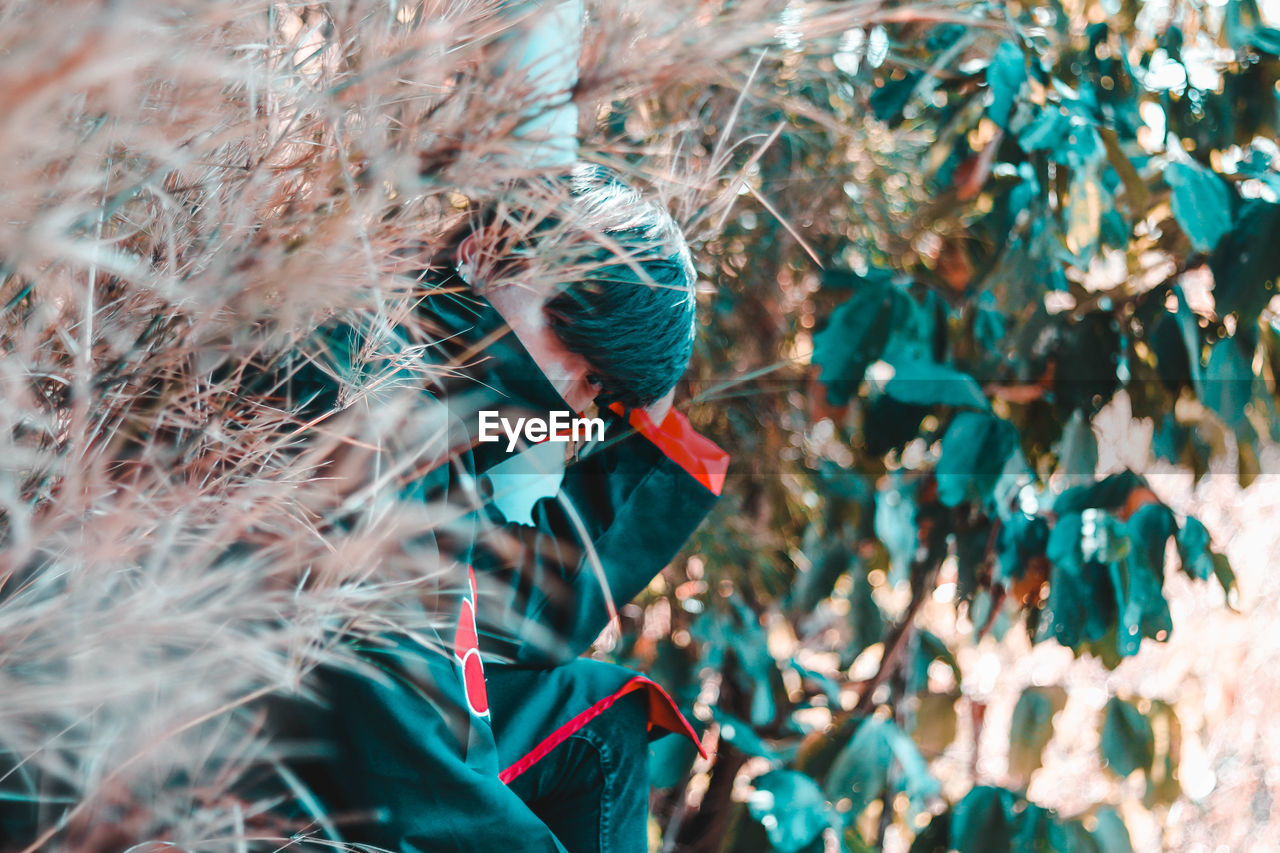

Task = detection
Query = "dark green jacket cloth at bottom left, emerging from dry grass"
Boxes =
[274,640,564,853]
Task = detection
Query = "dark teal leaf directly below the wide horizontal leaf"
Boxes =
[934,411,1018,506]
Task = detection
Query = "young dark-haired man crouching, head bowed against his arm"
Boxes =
[264,1,727,853]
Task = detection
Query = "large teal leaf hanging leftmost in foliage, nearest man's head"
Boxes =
[813,282,897,405]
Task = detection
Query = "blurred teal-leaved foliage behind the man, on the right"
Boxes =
[596,0,1280,853]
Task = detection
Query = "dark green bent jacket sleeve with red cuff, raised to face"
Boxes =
[481,411,728,666]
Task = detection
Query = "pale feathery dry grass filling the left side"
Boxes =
[0,0,942,850]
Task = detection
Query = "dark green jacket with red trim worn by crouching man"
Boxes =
[272,281,727,852]
